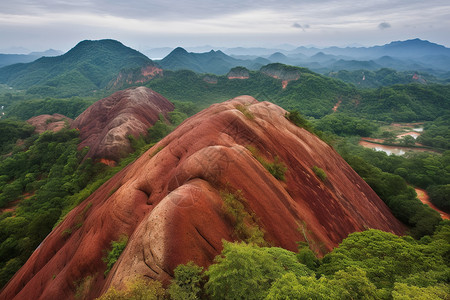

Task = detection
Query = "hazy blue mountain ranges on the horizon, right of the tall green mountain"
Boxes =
[154,39,450,78]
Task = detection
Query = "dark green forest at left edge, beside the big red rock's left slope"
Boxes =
[0,130,100,286]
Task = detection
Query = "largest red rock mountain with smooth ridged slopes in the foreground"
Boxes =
[0,96,405,299]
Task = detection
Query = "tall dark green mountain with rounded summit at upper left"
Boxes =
[0,40,155,97]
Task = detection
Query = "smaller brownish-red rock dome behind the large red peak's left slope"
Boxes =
[71,87,174,162]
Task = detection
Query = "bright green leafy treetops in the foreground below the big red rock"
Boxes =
[101,222,450,300]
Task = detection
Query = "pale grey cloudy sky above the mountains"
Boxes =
[0,0,450,53]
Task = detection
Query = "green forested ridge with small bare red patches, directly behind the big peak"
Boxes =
[146,64,450,122]
